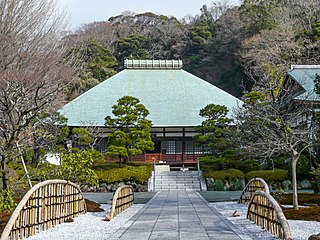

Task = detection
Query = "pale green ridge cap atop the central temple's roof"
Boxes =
[124,59,183,69]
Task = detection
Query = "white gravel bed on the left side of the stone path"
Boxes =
[27,204,143,240]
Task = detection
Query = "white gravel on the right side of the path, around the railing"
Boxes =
[210,202,320,240]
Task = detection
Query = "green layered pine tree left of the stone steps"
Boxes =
[105,96,154,163]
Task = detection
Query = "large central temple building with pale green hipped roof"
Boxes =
[60,60,242,165]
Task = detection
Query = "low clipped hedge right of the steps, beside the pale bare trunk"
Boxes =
[246,169,288,182]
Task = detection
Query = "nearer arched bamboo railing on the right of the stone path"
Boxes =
[247,191,292,240]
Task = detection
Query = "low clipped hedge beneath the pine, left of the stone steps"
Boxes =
[97,166,152,184]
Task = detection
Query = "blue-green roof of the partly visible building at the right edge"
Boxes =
[288,65,320,101]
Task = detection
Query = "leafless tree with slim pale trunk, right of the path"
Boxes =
[235,87,316,209]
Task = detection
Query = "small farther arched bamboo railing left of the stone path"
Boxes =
[106,185,134,221]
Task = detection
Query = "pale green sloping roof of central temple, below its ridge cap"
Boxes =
[60,69,242,126]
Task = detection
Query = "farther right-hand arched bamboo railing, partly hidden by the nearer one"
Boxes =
[238,178,270,204]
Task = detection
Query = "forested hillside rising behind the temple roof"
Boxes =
[65,0,320,98]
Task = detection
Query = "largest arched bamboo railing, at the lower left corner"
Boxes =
[1,180,86,240]
